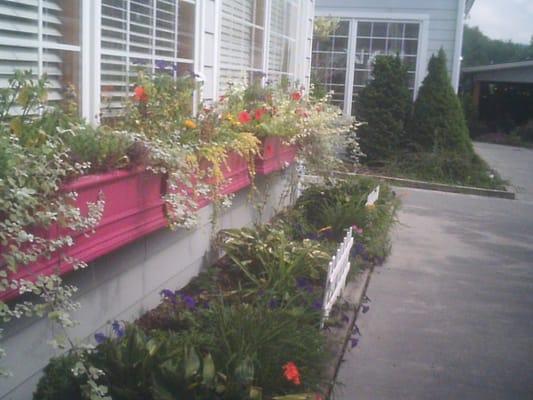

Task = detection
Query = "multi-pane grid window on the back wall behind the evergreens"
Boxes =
[312,19,421,114]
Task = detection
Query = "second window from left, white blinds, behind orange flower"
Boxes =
[101,0,196,117]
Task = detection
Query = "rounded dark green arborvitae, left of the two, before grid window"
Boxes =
[355,56,412,164]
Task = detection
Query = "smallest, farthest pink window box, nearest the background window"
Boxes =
[255,136,297,175]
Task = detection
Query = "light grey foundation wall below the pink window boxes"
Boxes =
[0,168,293,400]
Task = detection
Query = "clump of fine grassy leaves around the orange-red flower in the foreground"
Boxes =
[206,305,325,400]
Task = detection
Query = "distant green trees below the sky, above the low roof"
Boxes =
[463,26,533,67]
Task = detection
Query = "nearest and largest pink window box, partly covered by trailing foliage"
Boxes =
[0,169,167,300]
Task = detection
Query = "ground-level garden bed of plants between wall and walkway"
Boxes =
[34,178,398,400]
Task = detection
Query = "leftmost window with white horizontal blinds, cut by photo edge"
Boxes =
[0,0,83,108]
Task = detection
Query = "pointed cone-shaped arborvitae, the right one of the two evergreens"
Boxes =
[408,49,472,154]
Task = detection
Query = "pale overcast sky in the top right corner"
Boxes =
[467,0,533,44]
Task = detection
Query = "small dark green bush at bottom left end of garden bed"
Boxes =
[33,354,83,400]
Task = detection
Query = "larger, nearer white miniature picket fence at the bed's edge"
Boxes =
[321,228,353,327]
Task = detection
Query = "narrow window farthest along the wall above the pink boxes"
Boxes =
[268,0,298,82]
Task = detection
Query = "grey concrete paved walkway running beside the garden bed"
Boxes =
[335,144,533,400]
